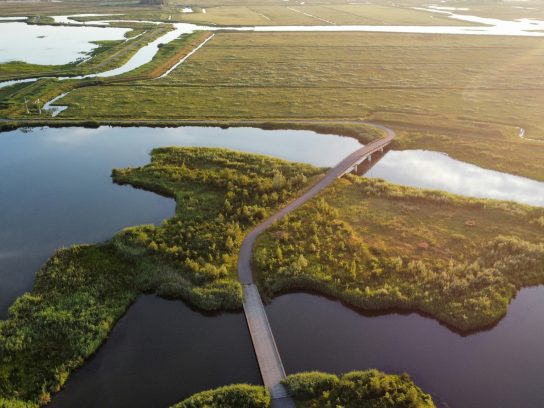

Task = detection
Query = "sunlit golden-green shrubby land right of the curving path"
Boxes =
[254,176,544,332]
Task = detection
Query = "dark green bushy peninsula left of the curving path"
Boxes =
[0,148,322,407]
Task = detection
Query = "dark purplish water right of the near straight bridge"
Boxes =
[267,286,544,408]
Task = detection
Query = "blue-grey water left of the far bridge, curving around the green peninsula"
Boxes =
[0,127,359,318]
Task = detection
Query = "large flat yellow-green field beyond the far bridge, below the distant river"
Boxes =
[58,33,544,180]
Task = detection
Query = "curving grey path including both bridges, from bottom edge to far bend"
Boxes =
[238,122,396,408]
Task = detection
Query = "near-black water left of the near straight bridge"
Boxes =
[51,295,261,408]
